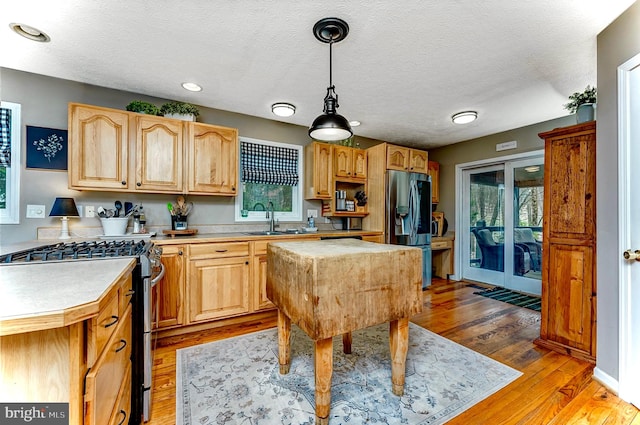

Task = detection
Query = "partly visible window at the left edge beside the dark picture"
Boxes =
[0,102,20,224]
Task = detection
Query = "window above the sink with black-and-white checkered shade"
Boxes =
[235,137,302,222]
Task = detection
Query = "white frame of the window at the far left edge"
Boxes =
[0,101,22,224]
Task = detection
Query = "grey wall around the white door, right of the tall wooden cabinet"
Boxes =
[596,2,640,380]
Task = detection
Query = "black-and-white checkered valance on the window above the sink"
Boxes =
[240,141,299,186]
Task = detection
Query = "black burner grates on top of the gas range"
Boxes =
[0,240,147,263]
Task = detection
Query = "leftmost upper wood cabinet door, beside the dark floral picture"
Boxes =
[69,103,130,190]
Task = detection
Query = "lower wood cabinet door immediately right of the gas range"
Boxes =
[153,245,186,329]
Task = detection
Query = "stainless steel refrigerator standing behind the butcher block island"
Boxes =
[385,170,431,289]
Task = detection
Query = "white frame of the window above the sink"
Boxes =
[234,136,304,223]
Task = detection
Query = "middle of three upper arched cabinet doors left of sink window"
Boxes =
[135,114,183,193]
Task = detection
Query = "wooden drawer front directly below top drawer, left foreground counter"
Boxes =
[84,308,131,425]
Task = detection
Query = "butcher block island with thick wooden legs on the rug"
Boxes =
[267,239,422,424]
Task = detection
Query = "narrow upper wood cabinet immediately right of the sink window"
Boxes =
[304,142,333,199]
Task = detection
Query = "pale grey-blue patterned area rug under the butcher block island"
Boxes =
[176,323,521,425]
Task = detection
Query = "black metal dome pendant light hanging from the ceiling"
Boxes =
[309,18,353,142]
